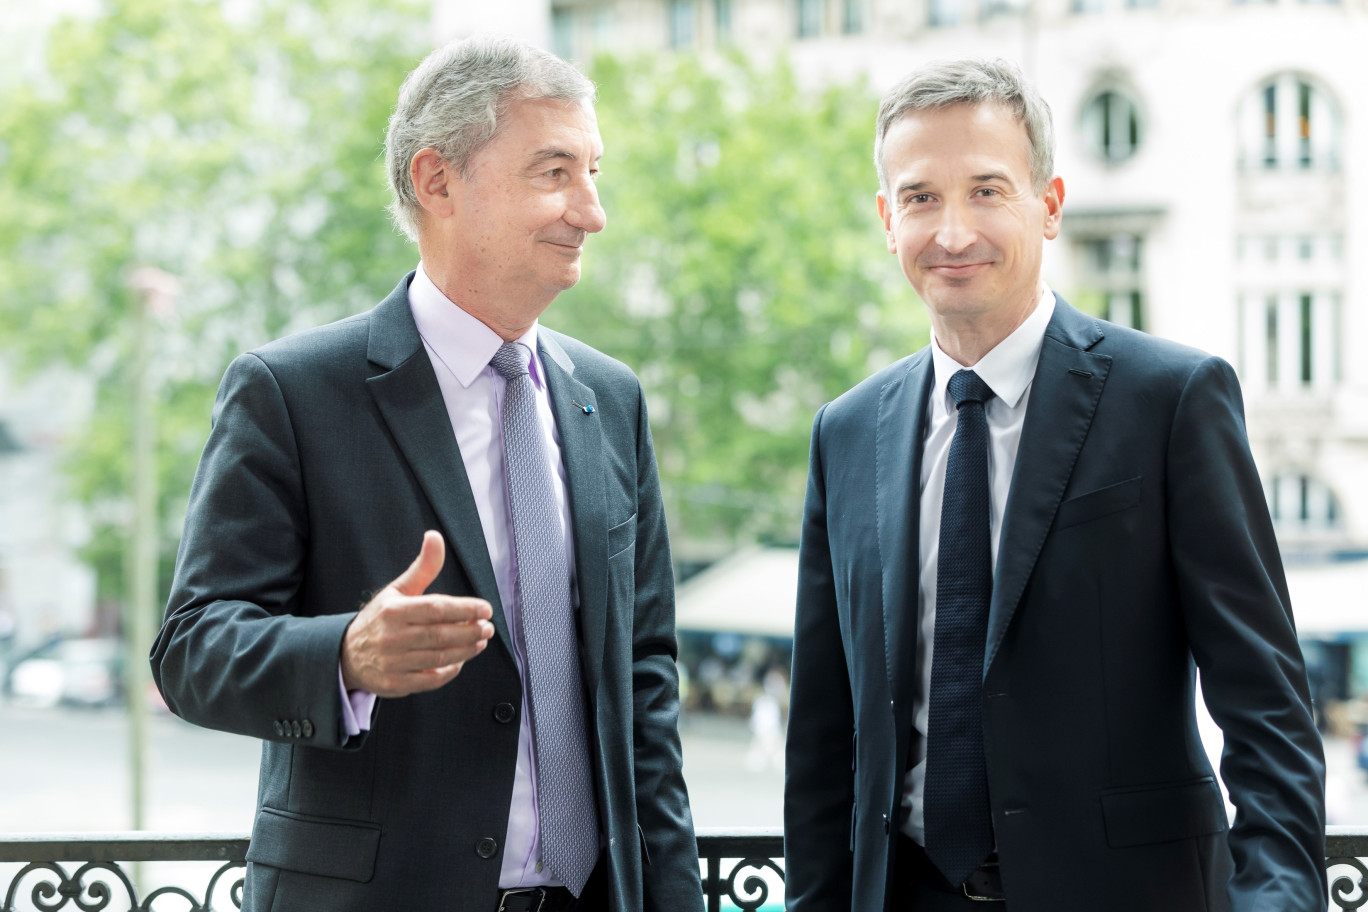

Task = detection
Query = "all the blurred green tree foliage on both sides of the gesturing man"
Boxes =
[0,10,925,607]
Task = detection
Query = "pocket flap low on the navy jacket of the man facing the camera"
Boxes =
[1103,777,1230,849]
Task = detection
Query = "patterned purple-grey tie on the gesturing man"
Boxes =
[490,342,599,896]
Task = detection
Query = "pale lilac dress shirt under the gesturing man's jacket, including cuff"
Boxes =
[342,263,579,889]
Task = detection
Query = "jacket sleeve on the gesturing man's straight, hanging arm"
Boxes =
[632,390,703,912]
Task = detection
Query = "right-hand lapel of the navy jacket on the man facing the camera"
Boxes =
[984,295,1111,677]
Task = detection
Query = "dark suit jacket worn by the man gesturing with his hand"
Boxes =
[152,273,702,912]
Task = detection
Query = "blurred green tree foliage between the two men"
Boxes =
[558,55,926,547]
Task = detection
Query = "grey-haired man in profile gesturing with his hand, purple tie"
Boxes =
[152,38,702,912]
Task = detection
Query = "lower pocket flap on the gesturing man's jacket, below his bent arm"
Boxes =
[248,808,380,883]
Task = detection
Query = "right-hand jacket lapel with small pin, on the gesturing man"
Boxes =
[538,328,607,694]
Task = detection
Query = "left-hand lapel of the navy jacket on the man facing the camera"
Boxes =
[874,349,934,737]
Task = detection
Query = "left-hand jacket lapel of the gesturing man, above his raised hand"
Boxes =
[367,273,513,644]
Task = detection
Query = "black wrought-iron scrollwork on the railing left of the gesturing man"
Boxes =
[0,861,246,912]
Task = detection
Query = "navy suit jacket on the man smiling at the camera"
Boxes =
[785,299,1326,912]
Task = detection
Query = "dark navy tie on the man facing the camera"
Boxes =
[922,371,993,885]
